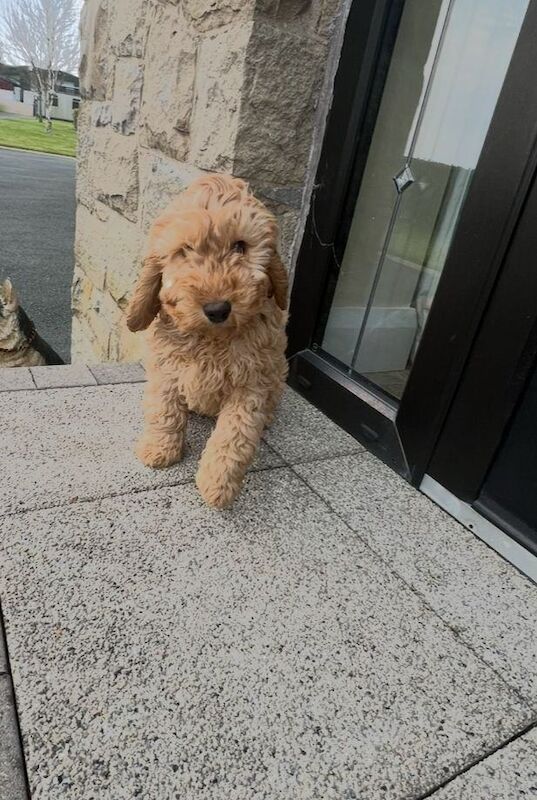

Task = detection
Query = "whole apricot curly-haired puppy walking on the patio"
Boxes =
[127,175,287,508]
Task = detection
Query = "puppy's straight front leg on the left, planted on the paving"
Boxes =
[136,370,188,467]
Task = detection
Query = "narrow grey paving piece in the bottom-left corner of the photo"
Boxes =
[0,675,28,800]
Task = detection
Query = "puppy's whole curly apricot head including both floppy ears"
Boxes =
[127,174,288,335]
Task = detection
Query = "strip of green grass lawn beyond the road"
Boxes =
[0,118,76,156]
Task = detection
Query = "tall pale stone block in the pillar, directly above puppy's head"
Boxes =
[190,23,251,172]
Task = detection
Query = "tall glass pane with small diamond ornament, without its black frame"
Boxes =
[322,0,529,397]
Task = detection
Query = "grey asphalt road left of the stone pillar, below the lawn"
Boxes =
[0,148,76,361]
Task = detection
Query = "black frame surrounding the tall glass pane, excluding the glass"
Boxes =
[289,0,537,485]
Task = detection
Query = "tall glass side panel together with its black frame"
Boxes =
[289,0,537,483]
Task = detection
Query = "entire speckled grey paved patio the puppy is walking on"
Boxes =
[0,365,537,800]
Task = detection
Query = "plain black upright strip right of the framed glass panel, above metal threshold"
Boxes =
[428,173,537,503]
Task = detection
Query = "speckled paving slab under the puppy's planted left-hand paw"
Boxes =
[0,384,281,513]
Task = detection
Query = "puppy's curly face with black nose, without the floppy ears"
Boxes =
[152,204,276,335]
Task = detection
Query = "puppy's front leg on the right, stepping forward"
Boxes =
[196,392,267,508]
